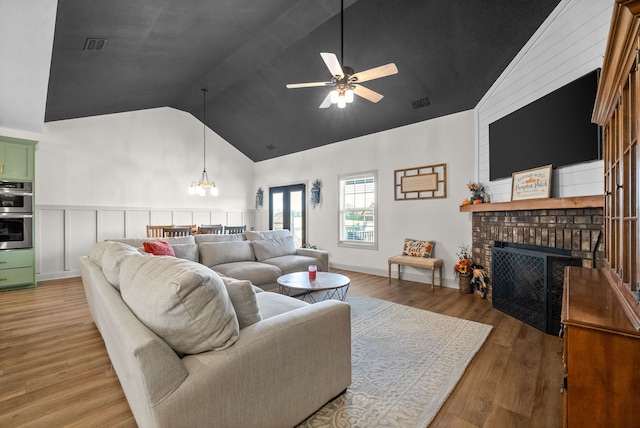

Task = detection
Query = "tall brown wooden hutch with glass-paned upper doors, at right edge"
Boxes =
[562,0,640,427]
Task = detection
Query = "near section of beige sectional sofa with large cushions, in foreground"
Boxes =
[80,237,351,428]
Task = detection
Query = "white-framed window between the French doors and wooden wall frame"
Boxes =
[338,171,378,249]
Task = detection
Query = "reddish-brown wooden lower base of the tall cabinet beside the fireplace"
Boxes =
[562,267,640,428]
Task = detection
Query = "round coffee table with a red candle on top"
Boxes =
[277,272,351,303]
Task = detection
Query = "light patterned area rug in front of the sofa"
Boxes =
[299,296,492,428]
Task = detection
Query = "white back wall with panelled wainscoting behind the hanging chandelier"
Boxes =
[35,108,254,280]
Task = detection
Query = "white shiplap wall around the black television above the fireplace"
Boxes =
[476,0,613,202]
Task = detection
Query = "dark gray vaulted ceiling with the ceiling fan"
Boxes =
[45,0,559,161]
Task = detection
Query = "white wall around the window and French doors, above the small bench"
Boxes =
[255,110,474,287]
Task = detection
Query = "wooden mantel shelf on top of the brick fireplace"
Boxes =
[460,195,604,212]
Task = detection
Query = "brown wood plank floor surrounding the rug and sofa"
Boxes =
[0,270,562,428]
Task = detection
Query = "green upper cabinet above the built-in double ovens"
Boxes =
[0,136,38,181]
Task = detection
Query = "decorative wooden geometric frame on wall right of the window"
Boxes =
[393,163,447,201]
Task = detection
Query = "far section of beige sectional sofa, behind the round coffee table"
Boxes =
[113,229,329,291]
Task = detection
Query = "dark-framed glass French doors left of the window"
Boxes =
[269,184,307,248]
